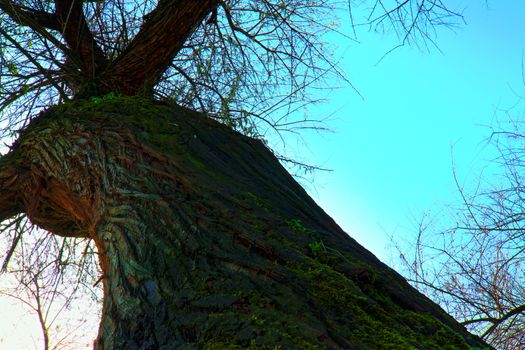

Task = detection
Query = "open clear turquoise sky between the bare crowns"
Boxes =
[296,0,525,262]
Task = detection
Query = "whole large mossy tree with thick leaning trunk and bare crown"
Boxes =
[0,0,485,349]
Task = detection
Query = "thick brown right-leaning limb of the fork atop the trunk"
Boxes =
[106,0,217,95]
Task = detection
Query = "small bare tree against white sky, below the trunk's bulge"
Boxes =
[0,216,102,350]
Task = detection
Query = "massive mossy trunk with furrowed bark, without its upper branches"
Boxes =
[0,97,492,349]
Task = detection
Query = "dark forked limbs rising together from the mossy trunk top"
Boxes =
[0,0,217,95]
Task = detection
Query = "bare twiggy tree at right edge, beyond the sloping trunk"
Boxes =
[396,111,525,349]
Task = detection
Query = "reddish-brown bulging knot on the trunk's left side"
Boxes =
[2,110,106,237]
